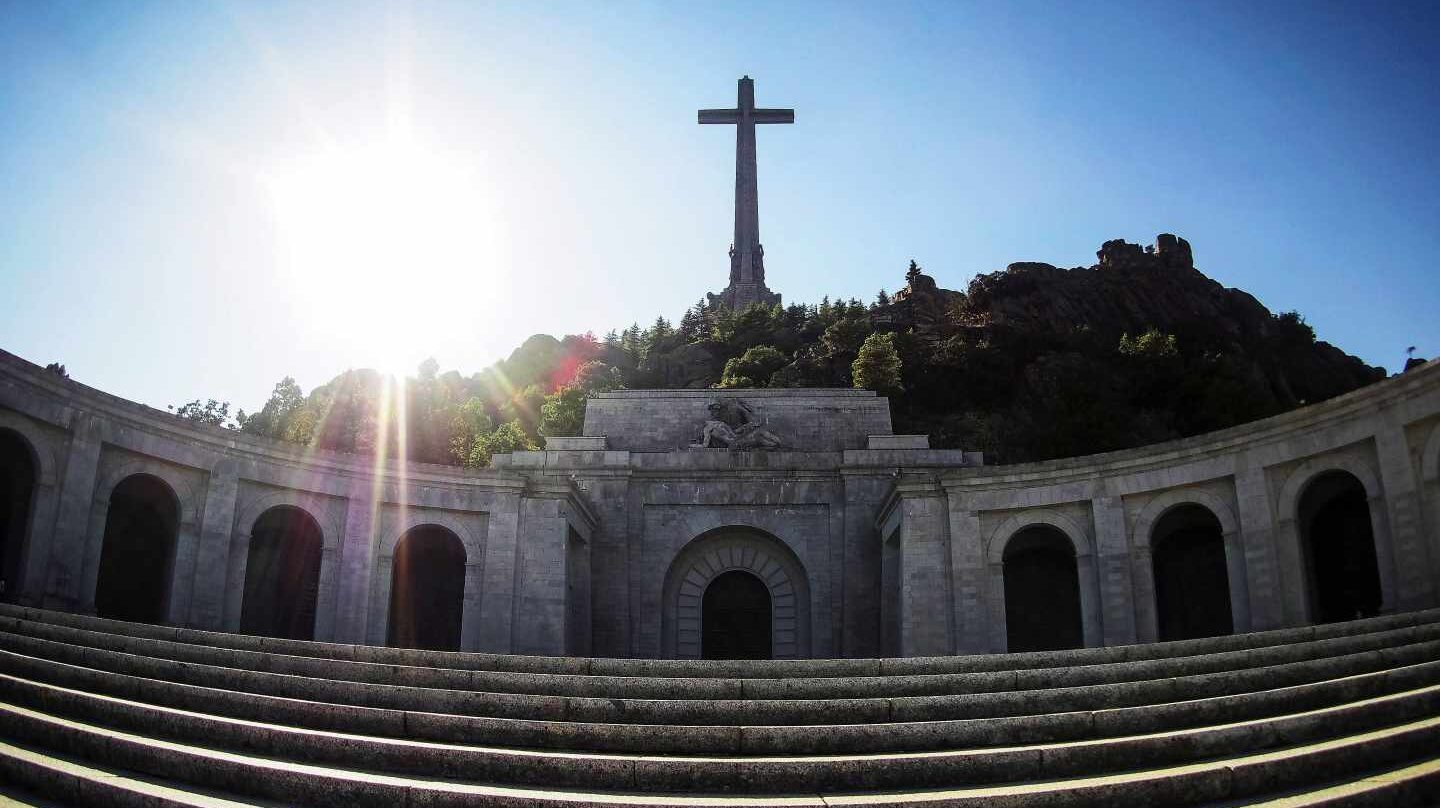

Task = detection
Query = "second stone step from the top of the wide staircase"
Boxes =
[0,616,1440,700]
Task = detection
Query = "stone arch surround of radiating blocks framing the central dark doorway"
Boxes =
[661,527,811,660]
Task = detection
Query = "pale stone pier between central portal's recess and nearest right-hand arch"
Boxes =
[897,481,955,657]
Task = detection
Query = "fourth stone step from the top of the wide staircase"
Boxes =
[0,642,1440,755]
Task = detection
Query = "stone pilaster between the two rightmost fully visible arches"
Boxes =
[1231,468,1305,631]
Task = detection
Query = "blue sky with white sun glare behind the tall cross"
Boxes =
[0,0,1440,409]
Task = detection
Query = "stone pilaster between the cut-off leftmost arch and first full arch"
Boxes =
[42,412,102,611]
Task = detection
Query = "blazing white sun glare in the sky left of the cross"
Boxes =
[266,141,504,373]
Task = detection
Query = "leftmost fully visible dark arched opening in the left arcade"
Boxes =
[95,474,180,622]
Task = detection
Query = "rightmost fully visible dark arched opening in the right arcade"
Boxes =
[1296,471,1381,622]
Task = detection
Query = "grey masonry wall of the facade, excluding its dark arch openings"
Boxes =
[0,354,1440,657]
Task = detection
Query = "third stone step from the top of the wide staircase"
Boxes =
[0,619,1440,726]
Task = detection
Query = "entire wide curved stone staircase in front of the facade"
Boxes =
[0,606,1440,808]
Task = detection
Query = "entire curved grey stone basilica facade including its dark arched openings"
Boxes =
[0,353,1440,658]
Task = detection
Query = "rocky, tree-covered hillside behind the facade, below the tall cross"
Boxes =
[177,236,1384,465]
